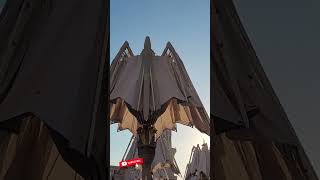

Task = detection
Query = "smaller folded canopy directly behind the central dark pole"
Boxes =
[125,130,180,178]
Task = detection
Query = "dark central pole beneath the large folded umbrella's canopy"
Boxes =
[138,125,156,180]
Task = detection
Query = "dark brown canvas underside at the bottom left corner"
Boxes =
[0,118,84,180]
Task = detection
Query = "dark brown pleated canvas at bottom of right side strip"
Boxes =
[212,134,293,180]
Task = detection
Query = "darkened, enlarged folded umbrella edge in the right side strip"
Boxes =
[211,0,318,180]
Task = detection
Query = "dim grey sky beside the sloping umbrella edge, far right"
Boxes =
[234,0,320,176]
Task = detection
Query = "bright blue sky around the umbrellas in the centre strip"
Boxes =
[110,0,210,179]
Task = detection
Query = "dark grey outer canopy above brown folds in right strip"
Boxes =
[213,0,297,143]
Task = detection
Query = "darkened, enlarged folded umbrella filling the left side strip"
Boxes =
[0,0,109,180]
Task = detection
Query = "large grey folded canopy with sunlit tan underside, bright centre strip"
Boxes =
[110,37,210,137]
